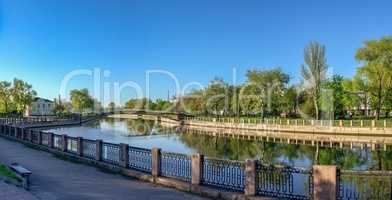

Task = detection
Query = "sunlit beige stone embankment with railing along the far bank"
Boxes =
[109,114,392,150]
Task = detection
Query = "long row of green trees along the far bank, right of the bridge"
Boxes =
[125,36,392,119]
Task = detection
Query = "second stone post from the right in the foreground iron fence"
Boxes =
[245,160,257,196]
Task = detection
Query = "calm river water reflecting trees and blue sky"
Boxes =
[46,118,392,170]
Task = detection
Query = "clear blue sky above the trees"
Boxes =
[0,0,392,104]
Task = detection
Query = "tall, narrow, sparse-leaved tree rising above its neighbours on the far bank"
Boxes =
[301,42,328,119]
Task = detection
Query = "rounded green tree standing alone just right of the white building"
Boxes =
[70,89,95,113]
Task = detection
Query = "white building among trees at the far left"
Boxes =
[26,97,54,116]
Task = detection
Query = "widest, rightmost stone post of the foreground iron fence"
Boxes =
[313,165,339,200]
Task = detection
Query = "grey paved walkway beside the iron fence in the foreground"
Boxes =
[0,137,208,200]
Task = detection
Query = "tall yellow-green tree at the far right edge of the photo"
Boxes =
[355,37,392,119]
